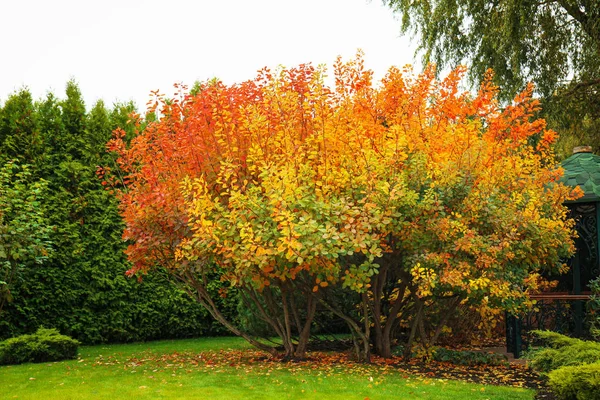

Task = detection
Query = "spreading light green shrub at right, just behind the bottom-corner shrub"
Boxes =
[528,331,600,373]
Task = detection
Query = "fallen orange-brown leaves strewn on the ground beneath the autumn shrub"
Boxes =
[94,349,544,389]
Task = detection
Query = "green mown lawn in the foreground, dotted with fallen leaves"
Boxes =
[0,338,534,400]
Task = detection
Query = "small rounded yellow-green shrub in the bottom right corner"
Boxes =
[548,363,600,400]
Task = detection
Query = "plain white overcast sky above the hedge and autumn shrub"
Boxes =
[0,0,415,108]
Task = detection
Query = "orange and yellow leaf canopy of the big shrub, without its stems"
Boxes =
[122,53,578,308]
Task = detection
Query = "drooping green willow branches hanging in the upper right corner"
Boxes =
[383,0,600,158]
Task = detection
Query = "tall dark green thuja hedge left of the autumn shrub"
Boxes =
[0,82,237,344]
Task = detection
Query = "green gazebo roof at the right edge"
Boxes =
[560,151,600,203]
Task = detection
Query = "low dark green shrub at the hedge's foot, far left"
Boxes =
[0,328,79,365]
